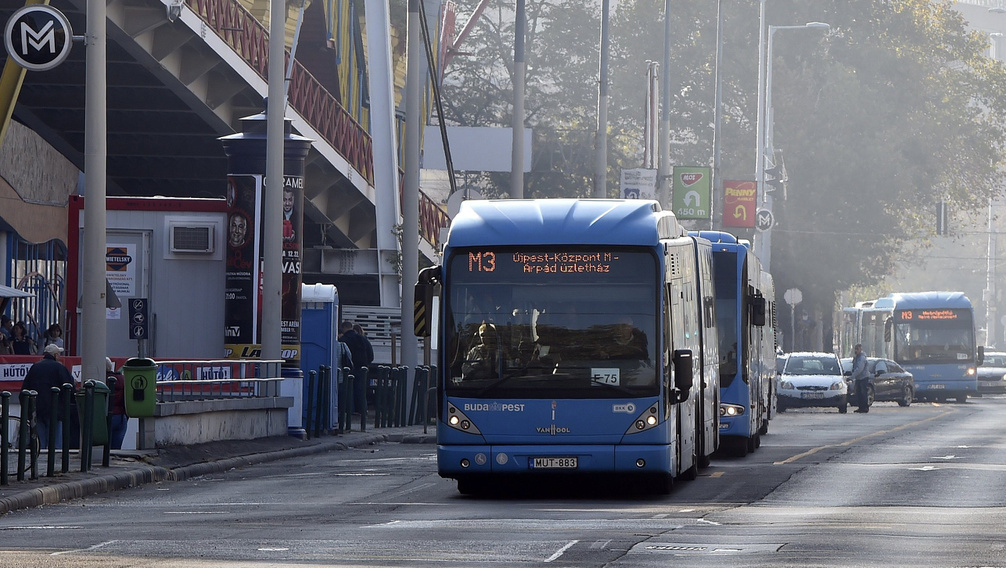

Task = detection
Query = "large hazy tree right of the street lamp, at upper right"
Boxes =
[772,0,1006,343]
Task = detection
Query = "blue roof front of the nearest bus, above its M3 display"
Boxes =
[447,199,686,246]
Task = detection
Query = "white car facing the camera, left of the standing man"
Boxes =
[777,352,849,414]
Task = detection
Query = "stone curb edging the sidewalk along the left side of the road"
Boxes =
[0,433,398,516]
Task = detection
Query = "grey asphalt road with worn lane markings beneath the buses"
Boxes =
[0,398,1006,568]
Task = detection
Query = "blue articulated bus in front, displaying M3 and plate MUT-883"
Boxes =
[416,199,718,493]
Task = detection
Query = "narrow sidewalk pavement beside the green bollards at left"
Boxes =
[0,425,437,516]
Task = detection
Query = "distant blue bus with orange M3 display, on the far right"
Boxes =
[845,292,984,402]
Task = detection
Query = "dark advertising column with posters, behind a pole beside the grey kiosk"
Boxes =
[220,114,311,368]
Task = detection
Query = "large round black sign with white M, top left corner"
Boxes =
[3,4,73,71]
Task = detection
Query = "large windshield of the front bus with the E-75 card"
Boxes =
[445,247,659,398]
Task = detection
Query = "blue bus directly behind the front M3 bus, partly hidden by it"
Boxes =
[692,231,777,456]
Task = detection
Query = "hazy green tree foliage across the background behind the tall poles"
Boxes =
[445,0,1006,327]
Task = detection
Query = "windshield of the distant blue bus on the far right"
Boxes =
[894,310,975,364]
